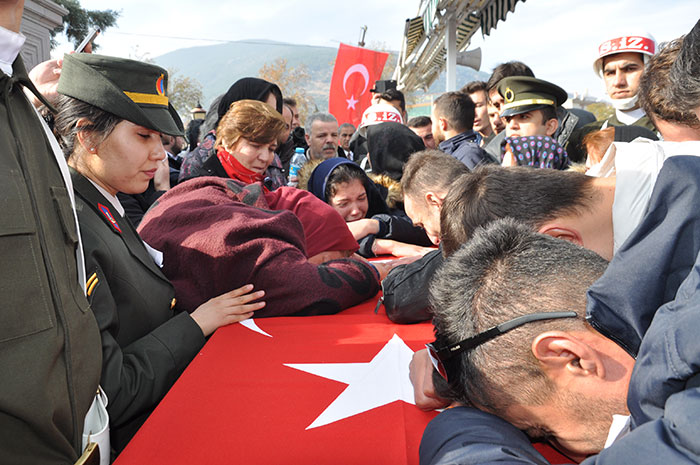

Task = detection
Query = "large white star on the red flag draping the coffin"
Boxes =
[285,334,415,430]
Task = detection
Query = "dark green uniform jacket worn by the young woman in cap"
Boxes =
[71,170,205,451]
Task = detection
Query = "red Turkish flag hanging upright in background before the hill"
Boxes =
[328,44,389,127]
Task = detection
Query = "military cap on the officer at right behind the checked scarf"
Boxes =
[498,76,568,117]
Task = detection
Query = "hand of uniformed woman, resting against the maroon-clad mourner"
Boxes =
[191,284,265,336]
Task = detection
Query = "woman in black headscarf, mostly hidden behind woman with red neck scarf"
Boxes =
[179,77,286,185]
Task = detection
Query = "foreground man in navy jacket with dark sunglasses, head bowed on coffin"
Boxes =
[420,213,700,465]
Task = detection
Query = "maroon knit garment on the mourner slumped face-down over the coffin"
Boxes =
[139,177,380,318]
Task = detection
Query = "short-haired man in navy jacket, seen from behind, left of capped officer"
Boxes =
[431,92,496,169]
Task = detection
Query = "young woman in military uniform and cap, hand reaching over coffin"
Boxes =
[56,54,264,451]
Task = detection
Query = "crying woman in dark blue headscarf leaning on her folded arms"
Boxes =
[301,157,432,257]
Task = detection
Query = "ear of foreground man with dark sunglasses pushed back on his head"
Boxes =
[532,331,605,378]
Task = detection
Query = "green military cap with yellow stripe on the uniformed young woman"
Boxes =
[57,53,184,136]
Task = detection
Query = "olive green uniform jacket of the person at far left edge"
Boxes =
[0,58,101,465]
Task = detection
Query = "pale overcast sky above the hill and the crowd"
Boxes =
[53,0,700,101]
